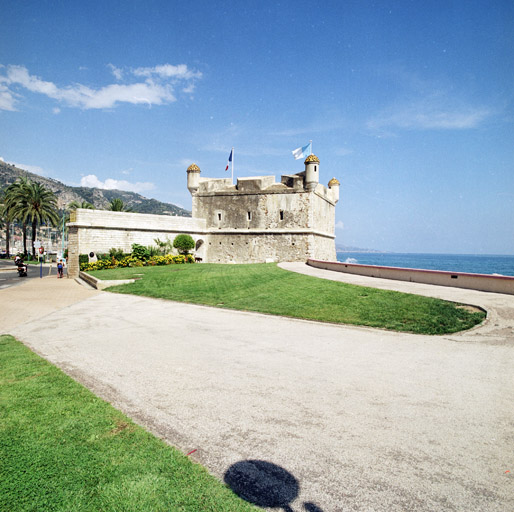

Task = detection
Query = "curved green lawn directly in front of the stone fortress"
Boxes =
[86,263,485,334]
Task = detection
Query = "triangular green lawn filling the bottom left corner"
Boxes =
[0,336,257,512]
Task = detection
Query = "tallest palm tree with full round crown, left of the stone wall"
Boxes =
[9,180,59,256]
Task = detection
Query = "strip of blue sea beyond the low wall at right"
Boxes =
[337,252,514,276]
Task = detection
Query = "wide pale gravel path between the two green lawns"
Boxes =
[0,269,514,512]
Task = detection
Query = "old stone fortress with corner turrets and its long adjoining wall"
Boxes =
[68,155,339,275]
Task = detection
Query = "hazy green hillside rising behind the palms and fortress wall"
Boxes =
[0,160,191,217]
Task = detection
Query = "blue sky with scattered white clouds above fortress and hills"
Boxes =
[0,0,514,254]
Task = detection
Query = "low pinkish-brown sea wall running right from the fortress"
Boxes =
[307,259,514,295]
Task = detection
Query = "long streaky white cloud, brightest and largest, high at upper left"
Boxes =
[0,64,201,110]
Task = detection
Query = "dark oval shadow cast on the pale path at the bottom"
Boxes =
[224,460,323,512]
